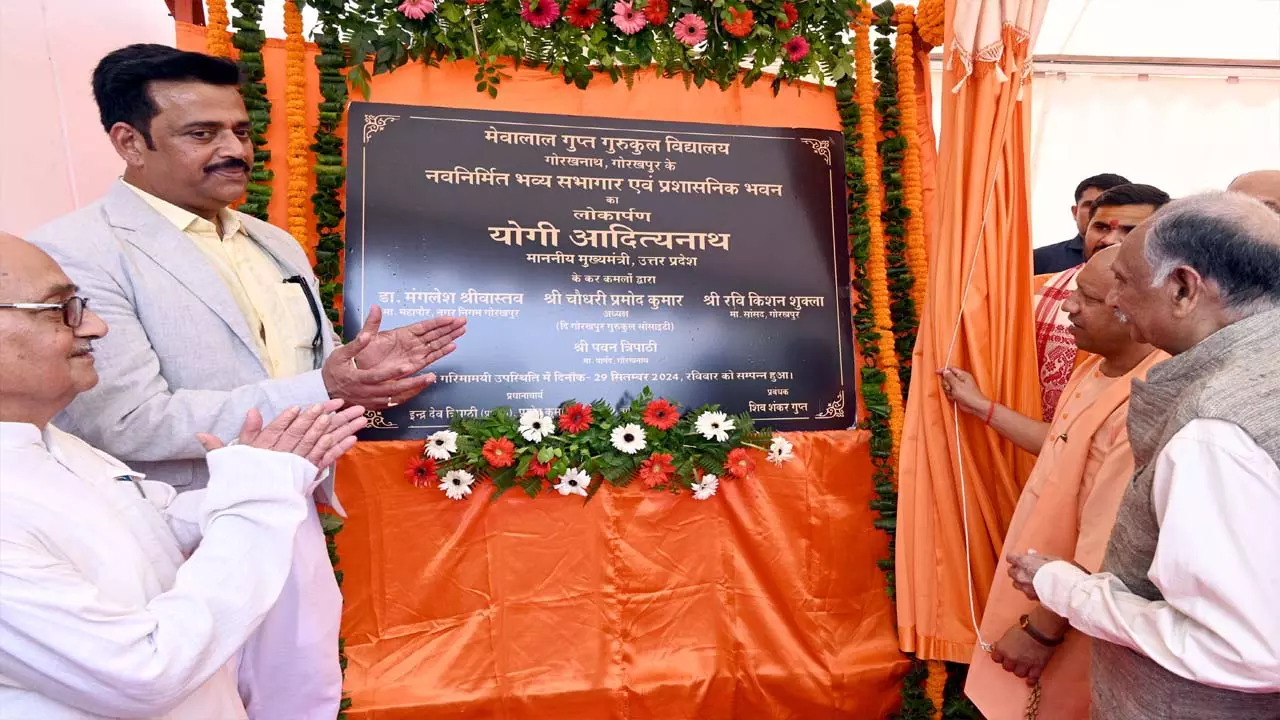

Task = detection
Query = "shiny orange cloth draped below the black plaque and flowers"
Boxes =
[338,432,906,720]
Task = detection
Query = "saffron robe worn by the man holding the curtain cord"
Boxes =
[965,351,1169,720]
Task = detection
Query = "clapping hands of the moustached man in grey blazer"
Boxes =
[320,305,467,410]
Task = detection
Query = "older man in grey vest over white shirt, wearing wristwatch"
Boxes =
[1010,192,1280,720]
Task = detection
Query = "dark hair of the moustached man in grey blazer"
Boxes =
[93,44,241,147]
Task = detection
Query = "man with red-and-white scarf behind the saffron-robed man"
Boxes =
[1036,184,1169,423]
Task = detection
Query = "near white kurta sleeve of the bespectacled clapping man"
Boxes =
[0,446,316,717]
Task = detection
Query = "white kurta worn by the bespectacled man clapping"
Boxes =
[0,423,316,720]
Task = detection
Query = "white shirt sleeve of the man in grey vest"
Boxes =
[1036,419,1280,693]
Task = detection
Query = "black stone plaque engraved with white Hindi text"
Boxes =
[344,102,855,439]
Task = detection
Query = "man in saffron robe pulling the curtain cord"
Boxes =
[942,247,1167,720]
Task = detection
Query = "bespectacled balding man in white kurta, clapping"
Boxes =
[0,233,364,720]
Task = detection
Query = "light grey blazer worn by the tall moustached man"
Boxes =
[28,181,337,491]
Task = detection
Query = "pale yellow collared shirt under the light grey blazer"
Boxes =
[124,183,316,378]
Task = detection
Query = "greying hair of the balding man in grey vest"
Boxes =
[1144,192,1280,315]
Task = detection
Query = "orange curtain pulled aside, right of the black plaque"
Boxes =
[896,0,1039,662]
